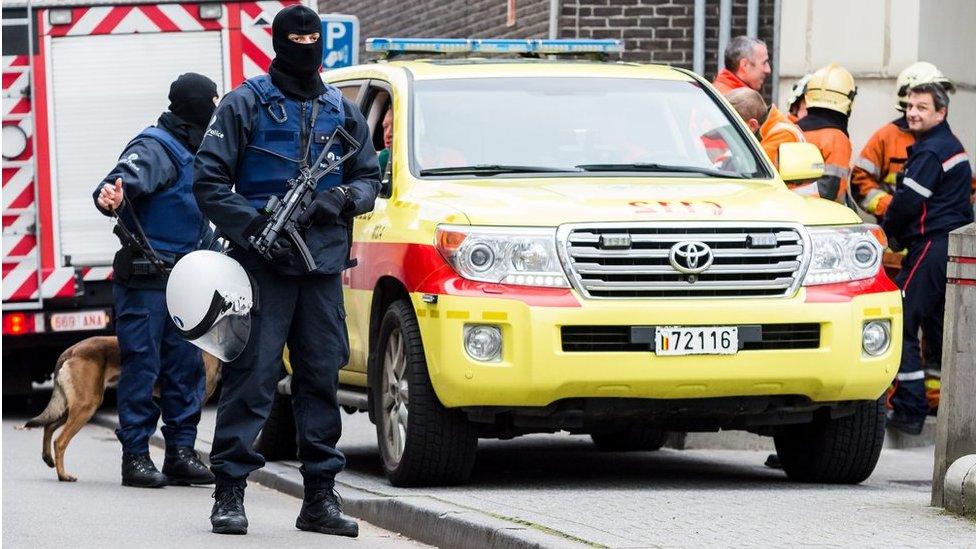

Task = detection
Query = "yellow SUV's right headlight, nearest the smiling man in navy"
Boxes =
[803,224,884,286]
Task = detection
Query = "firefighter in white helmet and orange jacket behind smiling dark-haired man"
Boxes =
[851,61,976,222]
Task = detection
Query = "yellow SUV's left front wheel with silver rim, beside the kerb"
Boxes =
[370,299,478,486]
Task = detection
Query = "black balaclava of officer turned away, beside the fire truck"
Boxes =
[159,72,217,152]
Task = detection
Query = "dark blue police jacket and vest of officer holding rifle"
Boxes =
[193,75,380,274]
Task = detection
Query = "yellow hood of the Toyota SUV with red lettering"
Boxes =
[418,177,861,226]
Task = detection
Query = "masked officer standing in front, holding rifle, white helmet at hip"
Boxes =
[193,5,380,536]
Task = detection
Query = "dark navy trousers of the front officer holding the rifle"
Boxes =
[210,260,349,487]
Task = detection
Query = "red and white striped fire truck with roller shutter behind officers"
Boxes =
[2,0,316,394]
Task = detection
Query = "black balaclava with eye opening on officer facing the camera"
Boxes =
[268,4,325,100]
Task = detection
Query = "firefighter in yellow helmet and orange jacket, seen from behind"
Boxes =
[797,63,857,203]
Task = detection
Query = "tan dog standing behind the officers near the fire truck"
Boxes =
[22,336,220,482]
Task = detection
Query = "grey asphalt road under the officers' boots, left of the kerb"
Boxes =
[2,402,423,549]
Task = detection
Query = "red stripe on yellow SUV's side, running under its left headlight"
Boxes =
[349,242,580,307]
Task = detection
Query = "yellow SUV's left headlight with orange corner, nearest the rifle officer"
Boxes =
[434,225,569,288]
